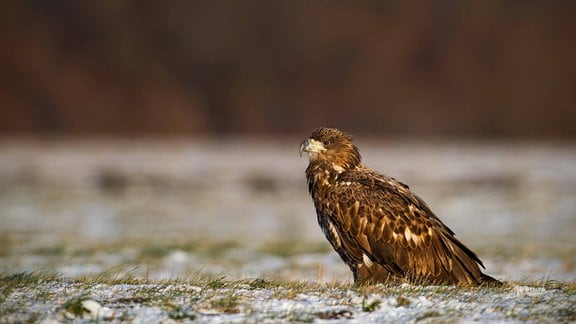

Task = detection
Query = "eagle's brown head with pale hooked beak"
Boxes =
[300,127,361,172]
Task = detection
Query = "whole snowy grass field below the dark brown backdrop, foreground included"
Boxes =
[0,138,576,322]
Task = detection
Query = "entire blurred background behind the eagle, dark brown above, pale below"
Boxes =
[0,0,576,280]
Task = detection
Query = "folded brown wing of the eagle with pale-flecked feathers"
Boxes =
[327,169,481,281]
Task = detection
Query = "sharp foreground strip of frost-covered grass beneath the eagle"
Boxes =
[0,274,576,322]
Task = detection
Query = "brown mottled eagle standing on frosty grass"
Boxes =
[300,127,501,286]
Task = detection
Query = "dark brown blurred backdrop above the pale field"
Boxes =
[0,0,576,138]
